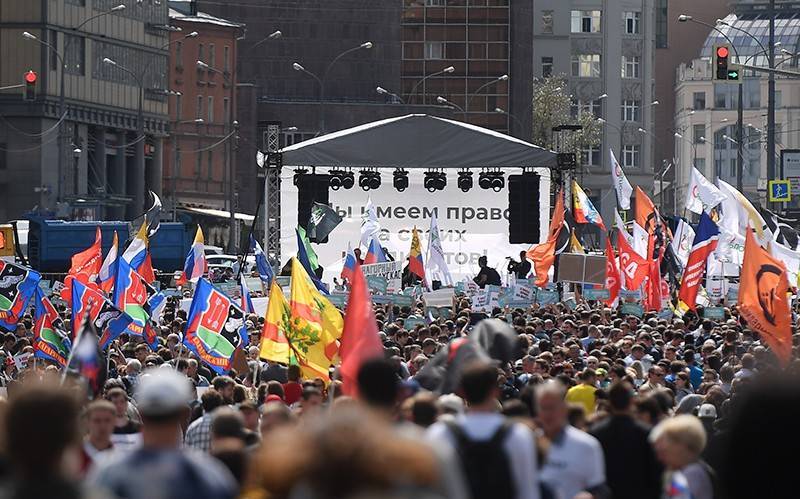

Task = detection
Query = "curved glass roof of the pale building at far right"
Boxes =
[700,12,800,67]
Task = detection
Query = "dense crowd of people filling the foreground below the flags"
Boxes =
[0,282,800,499]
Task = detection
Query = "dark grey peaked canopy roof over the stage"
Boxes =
[283,114,556,168]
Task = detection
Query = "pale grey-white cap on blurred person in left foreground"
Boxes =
[134,369,194,416]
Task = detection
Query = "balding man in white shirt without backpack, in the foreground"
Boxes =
[536,380,610,499]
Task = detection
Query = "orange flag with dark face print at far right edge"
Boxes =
[739,230,792,365]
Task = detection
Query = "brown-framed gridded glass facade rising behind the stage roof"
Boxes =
[401,0,534,139]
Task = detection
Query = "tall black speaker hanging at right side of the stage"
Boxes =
[508,173,540,244]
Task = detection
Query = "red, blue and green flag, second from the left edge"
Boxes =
[33,286,72,367]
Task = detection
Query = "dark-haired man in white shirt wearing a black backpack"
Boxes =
[427,362,539,499]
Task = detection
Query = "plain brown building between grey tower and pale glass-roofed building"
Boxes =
[653,0,730,213]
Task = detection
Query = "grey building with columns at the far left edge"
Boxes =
[0,0,169,219]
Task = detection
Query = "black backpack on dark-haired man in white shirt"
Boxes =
[445,421,516,499]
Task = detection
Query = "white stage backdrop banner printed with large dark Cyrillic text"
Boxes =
[281,168,550,282]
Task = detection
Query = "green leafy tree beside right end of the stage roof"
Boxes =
[531,75,602,164]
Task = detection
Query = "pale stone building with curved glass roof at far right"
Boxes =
[674,6,800,211]
